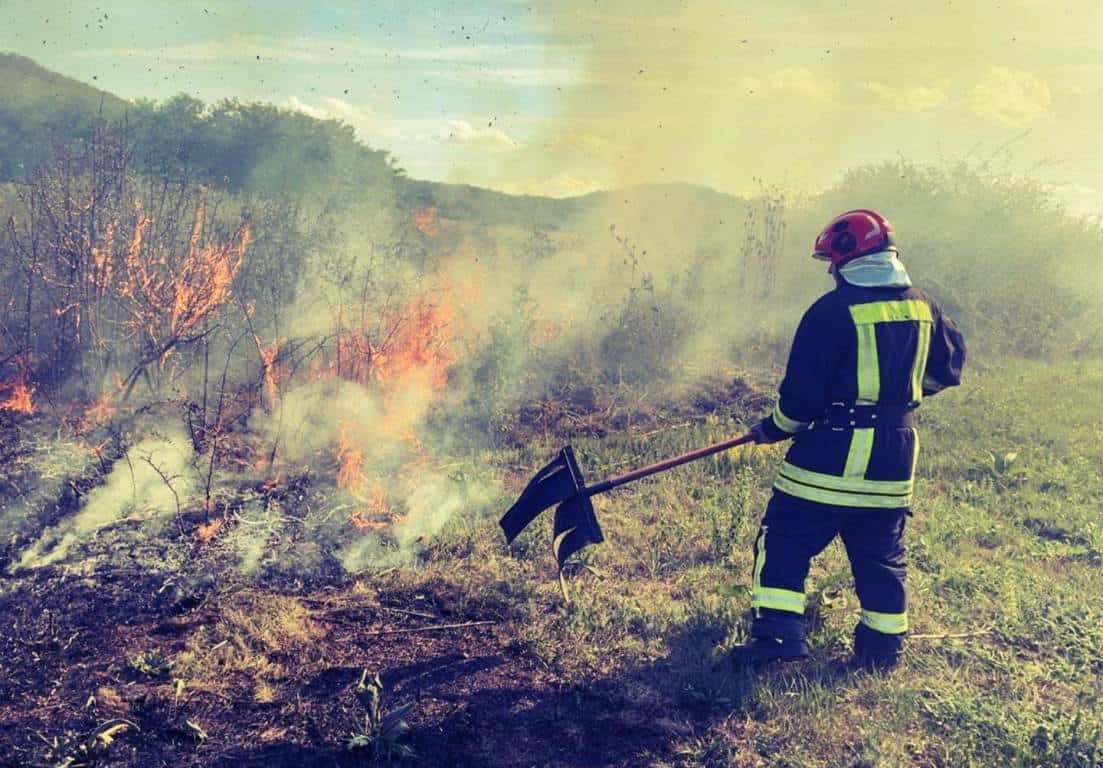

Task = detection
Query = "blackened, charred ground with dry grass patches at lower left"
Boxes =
[0,573,741,768]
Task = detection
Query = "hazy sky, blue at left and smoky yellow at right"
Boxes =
[0,0,1103,214]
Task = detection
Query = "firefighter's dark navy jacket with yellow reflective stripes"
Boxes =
[762,282,965,508]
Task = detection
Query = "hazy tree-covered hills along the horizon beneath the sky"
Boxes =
[0,54,745,231]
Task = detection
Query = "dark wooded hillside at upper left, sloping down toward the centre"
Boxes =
[0,54,399,193]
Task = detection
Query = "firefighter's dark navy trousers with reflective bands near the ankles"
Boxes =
[751,491,909,657]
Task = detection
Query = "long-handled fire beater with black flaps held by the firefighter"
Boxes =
[499,435,754,569]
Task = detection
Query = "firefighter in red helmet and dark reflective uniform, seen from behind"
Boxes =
[736,210,965,670]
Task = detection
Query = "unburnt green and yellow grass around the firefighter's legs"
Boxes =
[421,362,1103,768]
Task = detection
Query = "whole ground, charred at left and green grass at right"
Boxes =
[0,362,1103,768]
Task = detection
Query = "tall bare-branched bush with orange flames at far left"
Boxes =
[3,124,251,399]
